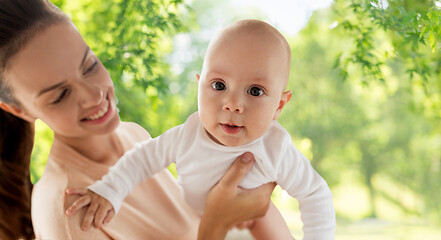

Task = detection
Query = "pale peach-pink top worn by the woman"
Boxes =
[32,123,199,240]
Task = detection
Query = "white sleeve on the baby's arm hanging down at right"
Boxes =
[277,144,335,240]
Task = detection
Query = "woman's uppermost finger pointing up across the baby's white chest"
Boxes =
[219,152,254,186]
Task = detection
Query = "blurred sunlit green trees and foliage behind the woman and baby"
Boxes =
[31,0,441,240]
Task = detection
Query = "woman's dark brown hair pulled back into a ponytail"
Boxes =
[0,0,68,239]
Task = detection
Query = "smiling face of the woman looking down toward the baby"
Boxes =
[4,22,120,138]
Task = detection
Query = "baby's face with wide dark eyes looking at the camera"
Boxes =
[198,25,291,146]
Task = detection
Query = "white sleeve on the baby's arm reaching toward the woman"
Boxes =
[89,128,177,213]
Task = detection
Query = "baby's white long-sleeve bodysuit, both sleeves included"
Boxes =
[89,112,335,240]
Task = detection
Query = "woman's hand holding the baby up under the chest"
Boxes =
[198,153,276,240]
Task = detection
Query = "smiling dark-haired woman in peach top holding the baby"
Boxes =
[0,0,274,239]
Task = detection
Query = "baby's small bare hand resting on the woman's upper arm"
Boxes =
[66,188,115,231]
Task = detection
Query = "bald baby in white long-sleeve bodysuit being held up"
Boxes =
[68,20,335,239]
